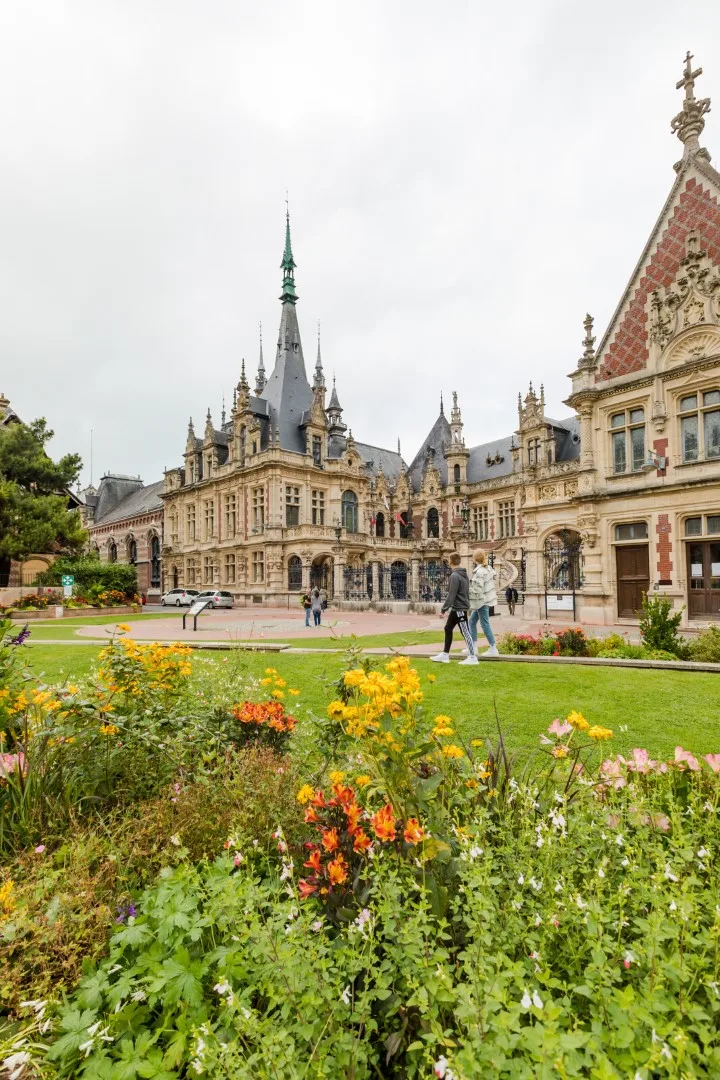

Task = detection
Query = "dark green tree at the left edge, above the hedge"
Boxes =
[0,420,87,565]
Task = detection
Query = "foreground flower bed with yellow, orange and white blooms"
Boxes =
[0,639,720,1080]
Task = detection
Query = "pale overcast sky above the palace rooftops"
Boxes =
[0,0,720,483]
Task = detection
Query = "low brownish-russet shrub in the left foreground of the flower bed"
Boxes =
[0,750,303,1014]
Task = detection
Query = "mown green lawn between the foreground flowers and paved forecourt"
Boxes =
[27,644,720,756]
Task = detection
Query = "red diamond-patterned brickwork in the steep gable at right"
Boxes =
[596,179,720,382]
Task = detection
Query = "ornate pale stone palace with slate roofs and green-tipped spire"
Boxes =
[90,54,720,624]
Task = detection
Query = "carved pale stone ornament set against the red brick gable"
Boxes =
[647,231,720,368]
